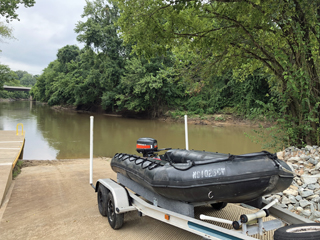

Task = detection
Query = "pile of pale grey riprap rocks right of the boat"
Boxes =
[264,146,320,222]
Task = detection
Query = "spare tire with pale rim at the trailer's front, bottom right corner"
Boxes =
[274,223,320,240]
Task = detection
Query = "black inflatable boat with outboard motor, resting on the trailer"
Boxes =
[111,138,293,203]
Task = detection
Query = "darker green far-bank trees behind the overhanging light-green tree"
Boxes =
[30,0,276,122]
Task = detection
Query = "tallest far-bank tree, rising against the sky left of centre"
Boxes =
[75,0,129,108]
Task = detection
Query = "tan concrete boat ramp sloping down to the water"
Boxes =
[0,159,201,240]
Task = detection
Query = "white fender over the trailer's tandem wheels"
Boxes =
[95,178,136,214]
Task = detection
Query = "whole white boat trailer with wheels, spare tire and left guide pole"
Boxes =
[89,117,320,240]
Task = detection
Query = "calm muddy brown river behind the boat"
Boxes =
[0,101,268,160]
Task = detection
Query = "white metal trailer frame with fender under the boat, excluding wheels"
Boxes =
[95,173,313,240]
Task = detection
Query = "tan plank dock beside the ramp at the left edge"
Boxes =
[0,126,25,207]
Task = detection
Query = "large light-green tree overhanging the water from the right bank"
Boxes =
[117,0,320,146]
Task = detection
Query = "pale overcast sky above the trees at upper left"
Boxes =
[0,0,86,75]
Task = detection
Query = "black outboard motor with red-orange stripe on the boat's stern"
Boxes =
[136,138,171,157]
